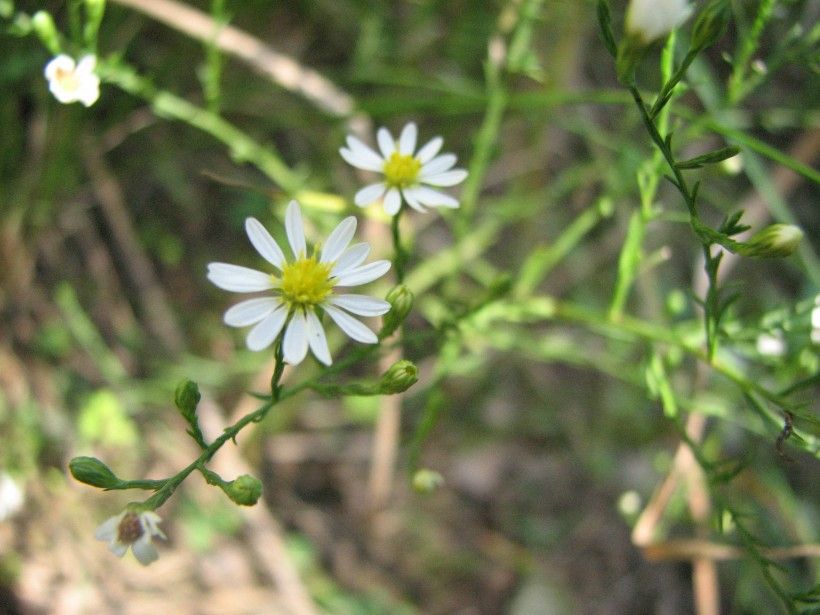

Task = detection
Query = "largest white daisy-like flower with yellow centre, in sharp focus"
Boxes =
[208,201,390,365]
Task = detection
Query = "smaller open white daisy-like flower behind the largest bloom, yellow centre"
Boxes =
[339,122,467,216]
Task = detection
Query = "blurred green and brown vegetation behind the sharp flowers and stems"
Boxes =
[0,0,820,615]
